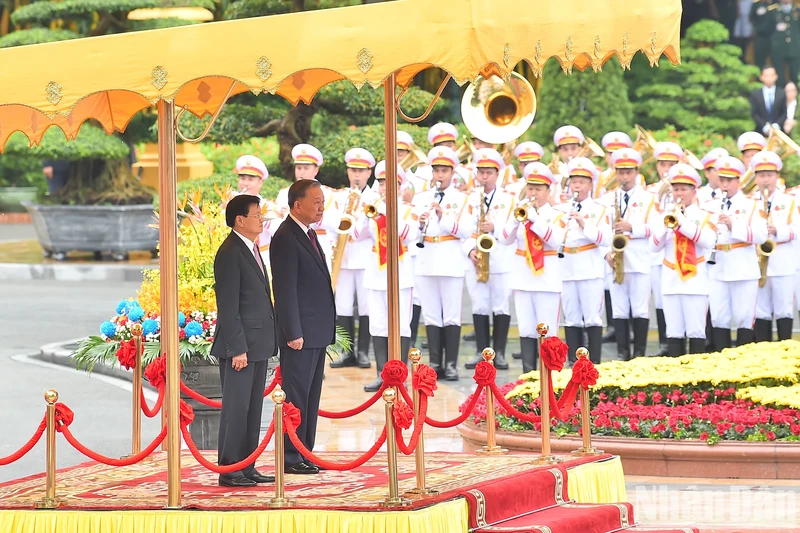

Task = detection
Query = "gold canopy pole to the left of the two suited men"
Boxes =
[158,100,181,509]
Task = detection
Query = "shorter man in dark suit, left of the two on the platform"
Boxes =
[211,194,278,487]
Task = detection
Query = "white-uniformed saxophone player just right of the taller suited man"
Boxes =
[331,148,378,368]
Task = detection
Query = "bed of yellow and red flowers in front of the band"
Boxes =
[462,341,800,444]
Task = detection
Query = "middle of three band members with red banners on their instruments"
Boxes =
[495,162,565,373]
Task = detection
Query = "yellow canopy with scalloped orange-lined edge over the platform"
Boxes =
[0,0,681,150]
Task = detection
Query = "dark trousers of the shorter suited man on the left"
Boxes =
[217,359,268,478]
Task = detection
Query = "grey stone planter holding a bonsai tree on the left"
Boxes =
[22,202,158,261]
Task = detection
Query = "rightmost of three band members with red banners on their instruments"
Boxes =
[651,163,714,357]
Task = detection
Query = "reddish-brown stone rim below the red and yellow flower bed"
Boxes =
[458,423,800,479]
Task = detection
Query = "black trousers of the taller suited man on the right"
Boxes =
[280,345,325,465]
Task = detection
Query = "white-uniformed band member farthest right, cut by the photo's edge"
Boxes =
[750,151,800,342]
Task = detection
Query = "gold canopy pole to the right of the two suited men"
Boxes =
[383,73,401,360]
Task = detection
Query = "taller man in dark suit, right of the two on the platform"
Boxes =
[269,180,336,474]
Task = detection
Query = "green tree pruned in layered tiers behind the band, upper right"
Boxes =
[629,20,759,137]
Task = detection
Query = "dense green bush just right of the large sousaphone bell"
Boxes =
[533,58,633,147]
